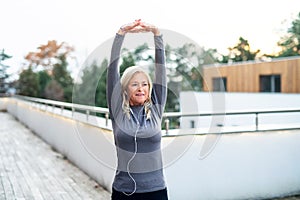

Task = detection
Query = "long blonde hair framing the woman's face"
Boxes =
[120,66,153,119]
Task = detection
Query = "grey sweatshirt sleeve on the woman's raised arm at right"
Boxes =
[152,35,167,116]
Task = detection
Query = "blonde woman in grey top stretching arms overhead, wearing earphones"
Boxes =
[107,20,168,200]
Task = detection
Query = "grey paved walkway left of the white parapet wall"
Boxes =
[0,112,110,200]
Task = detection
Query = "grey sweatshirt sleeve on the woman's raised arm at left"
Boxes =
[106,34,125,116]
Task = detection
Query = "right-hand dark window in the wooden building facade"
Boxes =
[259,75,281,92]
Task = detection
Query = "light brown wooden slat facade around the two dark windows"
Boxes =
[203,56,300,93]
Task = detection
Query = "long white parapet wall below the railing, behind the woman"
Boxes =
[0,99,300,200]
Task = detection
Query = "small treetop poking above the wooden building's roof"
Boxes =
[220,37,260,63]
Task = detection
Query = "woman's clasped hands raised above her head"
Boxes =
[118,19,160,36]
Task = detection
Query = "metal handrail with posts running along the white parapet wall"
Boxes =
[13,95,300,135]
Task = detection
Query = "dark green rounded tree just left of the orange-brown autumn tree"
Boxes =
[18,67,40,97]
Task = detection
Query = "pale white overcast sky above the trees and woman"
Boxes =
[0,0,300,77]
